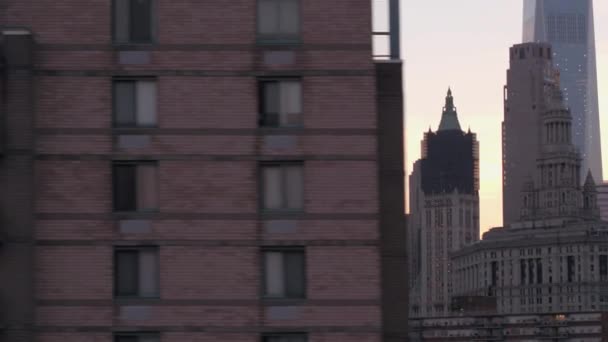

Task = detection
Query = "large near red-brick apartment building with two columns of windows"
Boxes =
[0,0,408,342]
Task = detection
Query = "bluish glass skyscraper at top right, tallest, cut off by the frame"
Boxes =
[523,0,603,181]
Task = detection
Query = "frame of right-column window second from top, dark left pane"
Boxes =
[257,76,304,129]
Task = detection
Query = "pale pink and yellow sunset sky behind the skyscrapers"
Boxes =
[401,0,608,233]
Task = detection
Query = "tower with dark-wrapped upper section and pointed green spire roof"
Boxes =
[408,90,479,317]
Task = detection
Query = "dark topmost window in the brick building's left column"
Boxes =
[113,0,155,44]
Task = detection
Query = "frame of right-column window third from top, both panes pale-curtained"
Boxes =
[258,160,306,214]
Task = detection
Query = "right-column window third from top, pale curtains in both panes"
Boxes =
[262,162,304,211]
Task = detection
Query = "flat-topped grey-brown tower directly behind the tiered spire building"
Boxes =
[502,43,559,226]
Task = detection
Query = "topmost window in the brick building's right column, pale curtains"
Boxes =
[258,0,300,43]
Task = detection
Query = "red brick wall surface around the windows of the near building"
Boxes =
[9,0,388,342]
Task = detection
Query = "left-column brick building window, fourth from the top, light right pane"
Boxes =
[114,247,159,298]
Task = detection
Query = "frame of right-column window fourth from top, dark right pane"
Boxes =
[260,246,308,302]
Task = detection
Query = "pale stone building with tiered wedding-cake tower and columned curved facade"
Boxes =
[452,63,608,314]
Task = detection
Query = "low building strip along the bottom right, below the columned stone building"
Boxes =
[409,312,608,342]
